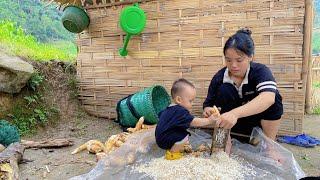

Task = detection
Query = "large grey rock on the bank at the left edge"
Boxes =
[0,52,34,94]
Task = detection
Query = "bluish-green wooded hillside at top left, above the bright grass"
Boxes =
[0,0,75,42]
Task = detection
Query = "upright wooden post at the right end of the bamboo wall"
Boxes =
[302,0,313,114]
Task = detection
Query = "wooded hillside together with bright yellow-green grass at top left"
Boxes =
[0,0,77,61]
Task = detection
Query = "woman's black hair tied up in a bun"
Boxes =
[223,28,254,57]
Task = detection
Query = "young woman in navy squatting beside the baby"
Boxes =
[203,29,283,143]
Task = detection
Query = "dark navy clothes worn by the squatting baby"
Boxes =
[155,105,194,149]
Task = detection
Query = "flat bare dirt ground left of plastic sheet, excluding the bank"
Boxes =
[19,113,121,180]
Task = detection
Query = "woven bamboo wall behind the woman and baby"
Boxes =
[77,0,305,134]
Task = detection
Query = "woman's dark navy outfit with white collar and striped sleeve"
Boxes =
[203,62,283,142]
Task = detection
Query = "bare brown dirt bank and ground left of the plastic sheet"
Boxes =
[15,61,121,180]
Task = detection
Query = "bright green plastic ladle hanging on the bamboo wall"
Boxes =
[119,3,146,56]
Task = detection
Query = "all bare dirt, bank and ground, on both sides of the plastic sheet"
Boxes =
[15,62,320,180]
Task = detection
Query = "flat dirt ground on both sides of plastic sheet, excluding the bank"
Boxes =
[19,111,320,180]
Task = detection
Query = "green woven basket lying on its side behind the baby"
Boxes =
[117,85,170,127]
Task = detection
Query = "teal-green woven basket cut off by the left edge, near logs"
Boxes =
[0,120,20,147]
